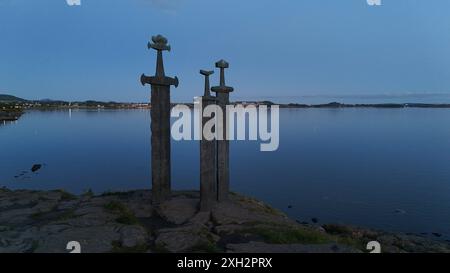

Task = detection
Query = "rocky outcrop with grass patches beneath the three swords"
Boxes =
[0,189,450,253]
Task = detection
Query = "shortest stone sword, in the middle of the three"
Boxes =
[200,70,217,211]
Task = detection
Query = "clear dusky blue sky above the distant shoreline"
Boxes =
[0,0,450,102]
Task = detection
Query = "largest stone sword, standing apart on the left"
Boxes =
[141,35,178,205]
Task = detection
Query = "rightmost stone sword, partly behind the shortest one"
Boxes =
[211,60,234,202]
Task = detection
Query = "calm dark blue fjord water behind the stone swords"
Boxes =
[0,108,450,238]
